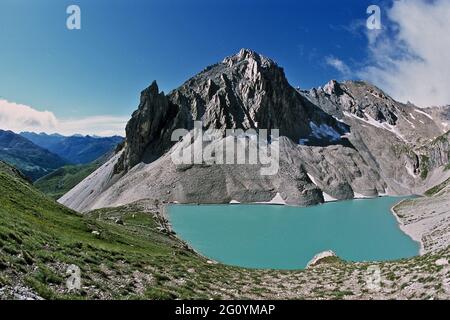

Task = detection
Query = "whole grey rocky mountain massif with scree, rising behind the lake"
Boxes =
[59,49,448,211]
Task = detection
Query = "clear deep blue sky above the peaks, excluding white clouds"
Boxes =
[0,0,450,135]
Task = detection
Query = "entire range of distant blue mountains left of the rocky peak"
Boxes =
[0,130,123,181]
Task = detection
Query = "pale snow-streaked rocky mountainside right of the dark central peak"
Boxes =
[301,80,448,194]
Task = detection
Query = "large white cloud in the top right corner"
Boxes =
[356,0,450,107]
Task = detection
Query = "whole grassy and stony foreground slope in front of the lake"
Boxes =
[0,163,450,299]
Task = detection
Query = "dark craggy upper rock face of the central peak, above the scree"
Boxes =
[116,49,348,173]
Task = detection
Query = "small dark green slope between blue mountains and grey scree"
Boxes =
[34,162,101,200]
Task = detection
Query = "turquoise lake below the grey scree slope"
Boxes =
[168,197,419,269]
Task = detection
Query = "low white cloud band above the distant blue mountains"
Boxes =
[0,99,129,136]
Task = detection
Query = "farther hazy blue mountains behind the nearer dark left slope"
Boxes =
[20,132,123,164]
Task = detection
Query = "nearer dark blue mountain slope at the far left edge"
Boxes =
[0,130,68,180]
